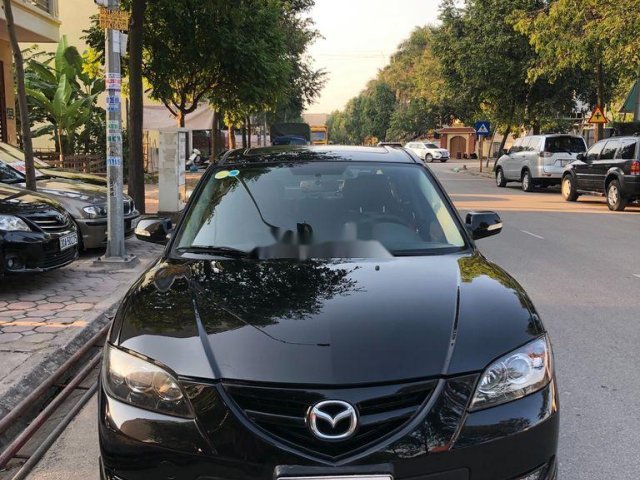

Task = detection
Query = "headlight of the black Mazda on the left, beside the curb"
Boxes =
[104,345,193,417]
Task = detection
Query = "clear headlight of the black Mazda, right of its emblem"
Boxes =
[471,336,553,410]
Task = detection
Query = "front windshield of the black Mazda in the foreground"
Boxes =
[174,162,465,255]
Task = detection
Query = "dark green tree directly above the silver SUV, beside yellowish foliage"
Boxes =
[435,0,581,154]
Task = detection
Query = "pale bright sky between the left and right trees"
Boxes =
[307,0,440,113]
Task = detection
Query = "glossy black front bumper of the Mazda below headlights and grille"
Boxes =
[99,376,559,480]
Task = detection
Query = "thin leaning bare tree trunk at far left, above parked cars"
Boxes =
[3,0,36,191]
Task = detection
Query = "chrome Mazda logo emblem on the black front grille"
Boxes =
[307,400,358,440]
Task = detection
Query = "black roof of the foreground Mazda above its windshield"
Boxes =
[218,145,418,164]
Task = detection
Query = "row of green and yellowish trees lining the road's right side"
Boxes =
[329,0,640,152]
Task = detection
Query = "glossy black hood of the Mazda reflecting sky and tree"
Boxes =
[111,254,542,385]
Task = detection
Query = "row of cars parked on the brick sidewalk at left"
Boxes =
[0,143,140,275]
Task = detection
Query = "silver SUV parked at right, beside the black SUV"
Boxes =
[496,135,587,192]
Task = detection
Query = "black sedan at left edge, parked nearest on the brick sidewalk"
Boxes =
[0,184,78,275]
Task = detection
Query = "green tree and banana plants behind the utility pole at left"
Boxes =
[11,0,325,208]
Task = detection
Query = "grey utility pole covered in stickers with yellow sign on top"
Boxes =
[96,0,135,264]
